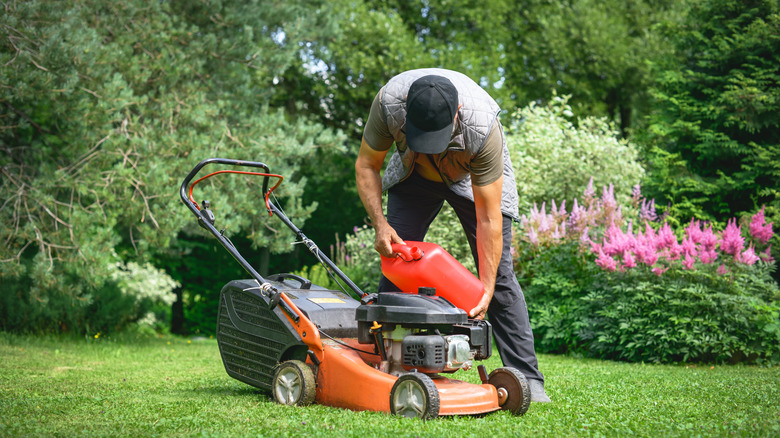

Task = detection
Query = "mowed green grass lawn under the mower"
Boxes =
[0,333,780,437]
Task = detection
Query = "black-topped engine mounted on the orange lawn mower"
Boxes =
[356,287,492,375]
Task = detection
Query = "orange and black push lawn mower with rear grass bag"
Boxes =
[180,158,530,419]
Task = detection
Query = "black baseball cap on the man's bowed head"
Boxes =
[406,75,458,154]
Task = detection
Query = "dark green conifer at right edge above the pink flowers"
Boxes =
[649,0,780,224]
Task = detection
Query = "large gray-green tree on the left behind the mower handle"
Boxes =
[0,0,343,332]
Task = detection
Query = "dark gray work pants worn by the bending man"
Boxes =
[379,172,544,381]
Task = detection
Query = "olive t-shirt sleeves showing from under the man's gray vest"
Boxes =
[363,90,504,187]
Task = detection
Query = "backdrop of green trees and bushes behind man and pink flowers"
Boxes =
[0,0,780,350]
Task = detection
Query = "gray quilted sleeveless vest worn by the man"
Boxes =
[380,68,518,220]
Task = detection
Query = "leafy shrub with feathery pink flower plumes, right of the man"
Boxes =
[516,181,780,362]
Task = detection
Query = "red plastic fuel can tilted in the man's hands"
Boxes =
[382,240,482,312]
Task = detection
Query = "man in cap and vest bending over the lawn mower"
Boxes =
[355,69,550,402]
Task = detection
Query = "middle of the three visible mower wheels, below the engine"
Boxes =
[390,373,439,420]
